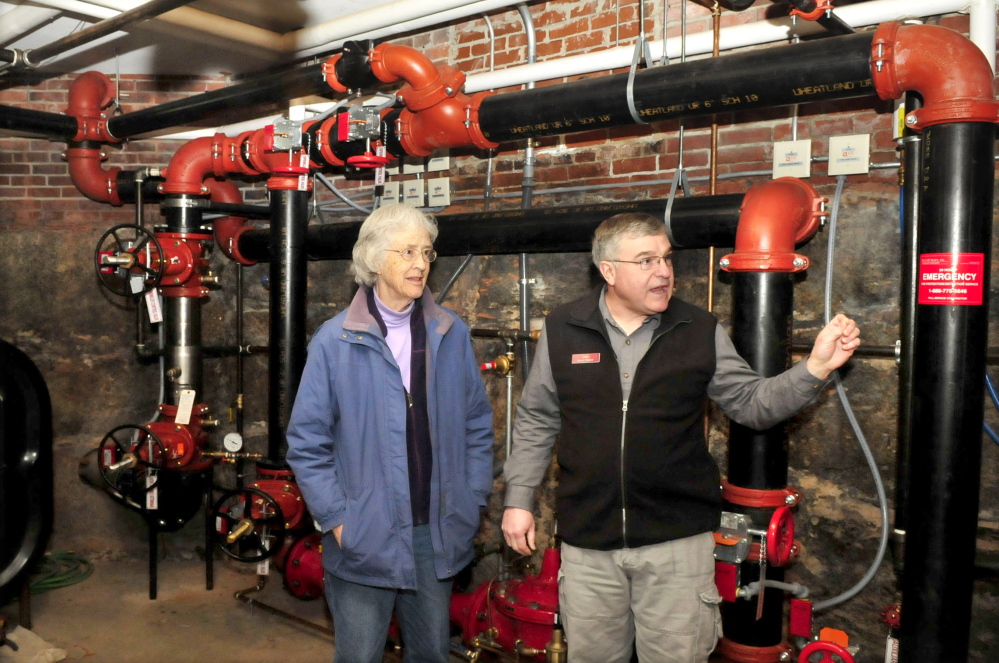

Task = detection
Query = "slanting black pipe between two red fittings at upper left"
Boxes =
[108,63,329,139]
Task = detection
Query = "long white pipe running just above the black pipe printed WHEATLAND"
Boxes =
[465,0,972,93]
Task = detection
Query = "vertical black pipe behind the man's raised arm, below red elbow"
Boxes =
[722,272,794,647]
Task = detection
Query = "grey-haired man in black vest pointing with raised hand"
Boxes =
[503,213,860,663]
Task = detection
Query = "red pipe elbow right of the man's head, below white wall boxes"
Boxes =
[721,177,826,272]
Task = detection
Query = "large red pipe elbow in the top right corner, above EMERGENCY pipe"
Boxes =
[871,21,999,129]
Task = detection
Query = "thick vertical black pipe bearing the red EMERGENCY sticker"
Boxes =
[899,122,995,663]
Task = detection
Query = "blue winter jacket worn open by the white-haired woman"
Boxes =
[287,286,493,589]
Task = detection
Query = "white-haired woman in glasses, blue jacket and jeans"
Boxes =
[287,205,493,663]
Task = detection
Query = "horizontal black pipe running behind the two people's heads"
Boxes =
[239,194,744,262]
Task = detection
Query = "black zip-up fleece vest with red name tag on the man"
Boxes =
[545,290,721,550]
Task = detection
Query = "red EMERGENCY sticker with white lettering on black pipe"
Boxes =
[919,253,985,306]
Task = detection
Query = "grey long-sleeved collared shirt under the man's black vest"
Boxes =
[504,294,828,511]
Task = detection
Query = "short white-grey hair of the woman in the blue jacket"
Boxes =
[350,204,437,287]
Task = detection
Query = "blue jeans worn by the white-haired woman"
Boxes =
[325,525,452,663]
